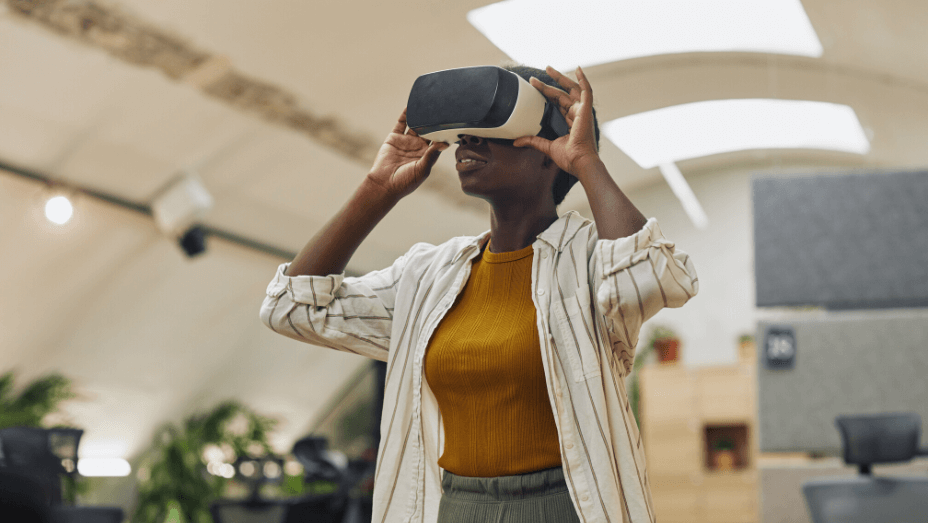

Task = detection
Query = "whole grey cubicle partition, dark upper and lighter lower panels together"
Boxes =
[753,171,928,454]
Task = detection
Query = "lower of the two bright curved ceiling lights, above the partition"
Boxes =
[601,99,870,169]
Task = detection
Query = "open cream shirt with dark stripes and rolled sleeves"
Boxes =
[261,211,698,523]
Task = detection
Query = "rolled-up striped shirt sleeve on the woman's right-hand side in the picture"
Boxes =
[590,218,699,372]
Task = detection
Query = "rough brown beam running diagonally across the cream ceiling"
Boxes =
[0,0,486,214]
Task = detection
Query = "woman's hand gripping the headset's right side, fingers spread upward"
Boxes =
[513,66,600,178]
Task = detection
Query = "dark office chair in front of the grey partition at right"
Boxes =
[802,413,928,523]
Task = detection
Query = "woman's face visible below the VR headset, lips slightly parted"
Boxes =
[454,135,559,202]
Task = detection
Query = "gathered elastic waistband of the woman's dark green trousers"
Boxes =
[441,467,567,501]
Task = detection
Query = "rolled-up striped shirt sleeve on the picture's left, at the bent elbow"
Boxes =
[260,256,406,361]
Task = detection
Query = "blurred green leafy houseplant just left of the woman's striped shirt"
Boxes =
[132,401,277,523]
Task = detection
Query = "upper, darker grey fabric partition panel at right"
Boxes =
[753,172,928,310]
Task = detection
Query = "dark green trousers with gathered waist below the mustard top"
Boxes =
[438,467,580,523]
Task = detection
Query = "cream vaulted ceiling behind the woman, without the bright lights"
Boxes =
[0,0,928,470]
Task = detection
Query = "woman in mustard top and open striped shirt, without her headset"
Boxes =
[261,67,698,523]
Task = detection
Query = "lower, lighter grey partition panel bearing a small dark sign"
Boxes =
[757,309,928,455]
